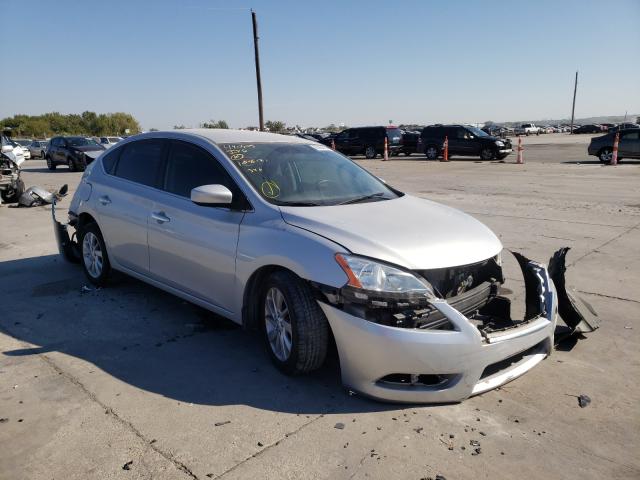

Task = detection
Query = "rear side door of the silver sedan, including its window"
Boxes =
[92,139,167,275]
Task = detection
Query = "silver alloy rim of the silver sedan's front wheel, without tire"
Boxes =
[264,287,293,362]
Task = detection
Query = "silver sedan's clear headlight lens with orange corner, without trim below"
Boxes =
[335,253,434,300]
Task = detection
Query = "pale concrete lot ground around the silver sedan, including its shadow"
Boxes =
[0,134,640,480]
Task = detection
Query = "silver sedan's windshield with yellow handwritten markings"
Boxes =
[219,143,398,206]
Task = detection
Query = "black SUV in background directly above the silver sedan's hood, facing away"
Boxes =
[333,127,402,158]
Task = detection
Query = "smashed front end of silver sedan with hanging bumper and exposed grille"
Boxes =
[317,249,597,402]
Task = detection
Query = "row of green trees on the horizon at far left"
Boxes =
[0,111,141,138]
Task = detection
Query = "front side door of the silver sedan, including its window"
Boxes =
[149,140,244,312]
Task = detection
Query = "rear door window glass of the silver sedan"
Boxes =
[115,139,165,187]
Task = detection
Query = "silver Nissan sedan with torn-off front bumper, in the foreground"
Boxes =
[54,129,595,402]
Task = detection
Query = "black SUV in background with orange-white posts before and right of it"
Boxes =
[420,124,513,160]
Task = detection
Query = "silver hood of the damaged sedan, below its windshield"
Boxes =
[280,195,502,270]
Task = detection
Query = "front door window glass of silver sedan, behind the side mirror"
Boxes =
[164,140,234,198]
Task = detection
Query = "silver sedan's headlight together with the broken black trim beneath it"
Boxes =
[335,253,434,307]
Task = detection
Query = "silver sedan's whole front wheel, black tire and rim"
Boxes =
[258,271,329,375]
